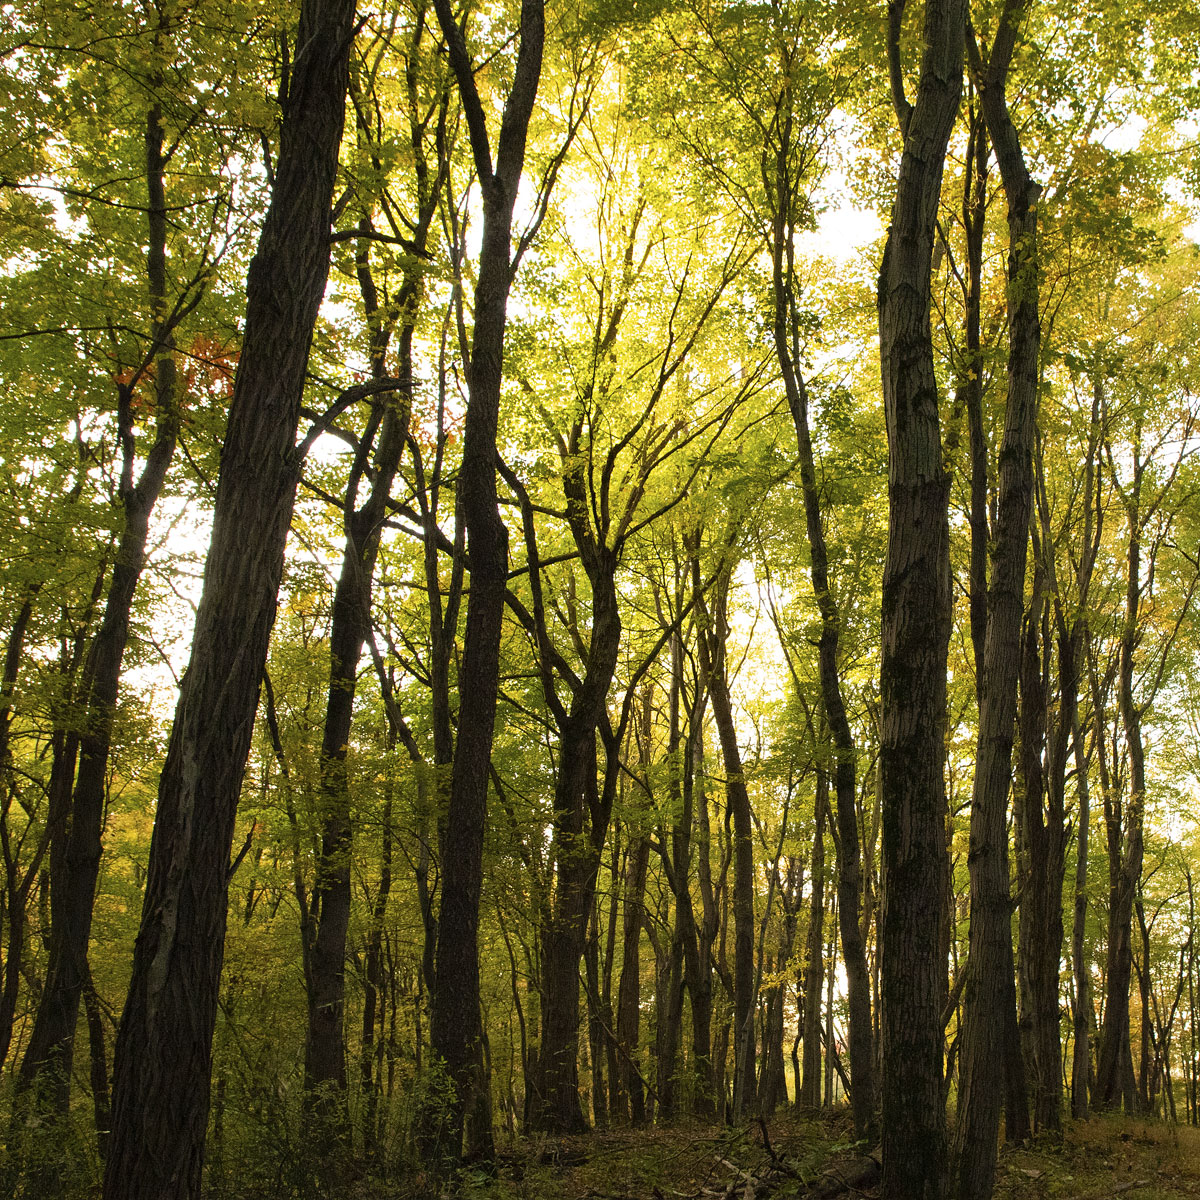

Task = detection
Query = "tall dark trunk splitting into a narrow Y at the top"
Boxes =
[431,0,544,1158]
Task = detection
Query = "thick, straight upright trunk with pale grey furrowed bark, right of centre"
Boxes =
[878,0,964,1200]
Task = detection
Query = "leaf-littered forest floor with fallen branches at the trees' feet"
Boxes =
[396,1114,1200,1200]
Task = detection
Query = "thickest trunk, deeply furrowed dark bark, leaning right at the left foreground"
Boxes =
[104,0,354,1200]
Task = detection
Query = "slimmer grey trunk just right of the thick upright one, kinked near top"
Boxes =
[955,0,1040,1200]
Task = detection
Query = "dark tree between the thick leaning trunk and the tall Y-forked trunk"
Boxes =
[304,20,449,1145]
